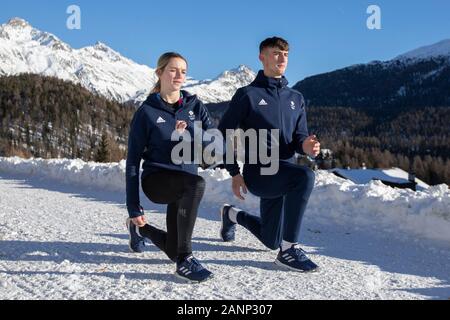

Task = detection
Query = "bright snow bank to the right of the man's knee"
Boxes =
[308,171,450,243]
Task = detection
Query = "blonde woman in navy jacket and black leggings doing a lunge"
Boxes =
[126,52,212,282]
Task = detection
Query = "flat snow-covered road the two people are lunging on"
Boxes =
[0,173,450,299]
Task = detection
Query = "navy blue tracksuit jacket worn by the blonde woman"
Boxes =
[126,91,213,217]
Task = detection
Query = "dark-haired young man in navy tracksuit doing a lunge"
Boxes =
[219,37,320,272]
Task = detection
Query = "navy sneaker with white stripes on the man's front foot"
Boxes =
[275,244,319,272]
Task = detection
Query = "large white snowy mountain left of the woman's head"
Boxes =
[0,18,155,102]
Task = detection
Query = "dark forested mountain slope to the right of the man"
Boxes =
[294,40,450,109]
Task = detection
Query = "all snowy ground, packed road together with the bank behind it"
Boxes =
[0,158,450,300]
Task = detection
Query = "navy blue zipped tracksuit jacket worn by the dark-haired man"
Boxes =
[219,71,308,176]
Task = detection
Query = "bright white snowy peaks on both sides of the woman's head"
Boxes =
[0,18,256,104]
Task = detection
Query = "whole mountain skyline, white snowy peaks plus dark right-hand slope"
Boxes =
[0,18,450,113]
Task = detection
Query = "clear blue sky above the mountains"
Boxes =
[0,0,450,84]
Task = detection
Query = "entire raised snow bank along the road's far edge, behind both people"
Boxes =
[0,157,450,243]
